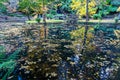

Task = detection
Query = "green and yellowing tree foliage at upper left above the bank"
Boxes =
[19,0,54,20]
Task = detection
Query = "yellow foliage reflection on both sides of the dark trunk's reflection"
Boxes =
[70,27,95,52]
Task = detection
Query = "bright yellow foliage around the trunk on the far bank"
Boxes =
[71,0,97,17]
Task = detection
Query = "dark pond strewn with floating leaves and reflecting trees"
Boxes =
[0,24,120,80]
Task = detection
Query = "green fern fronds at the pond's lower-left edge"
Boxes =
[0,48,22,80]
